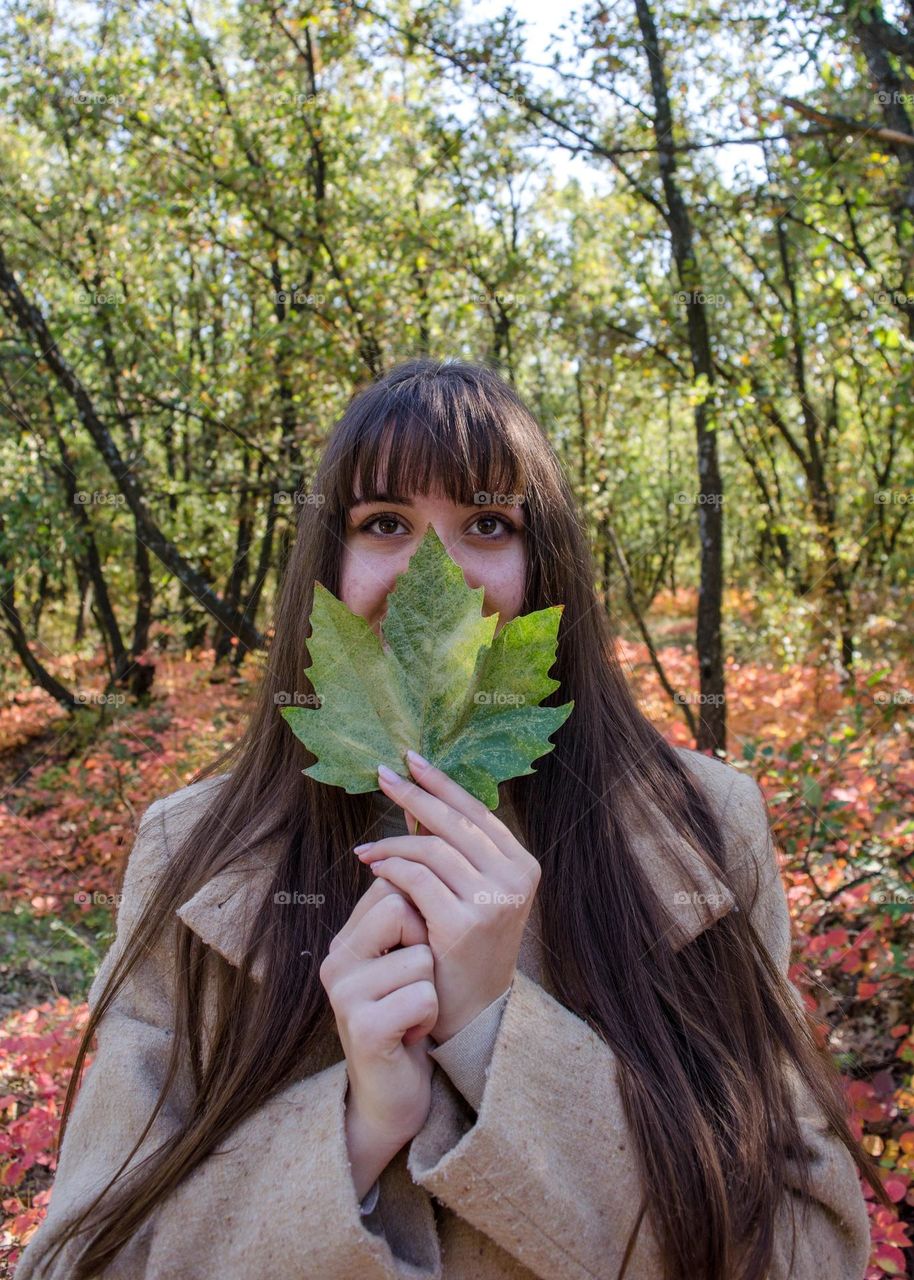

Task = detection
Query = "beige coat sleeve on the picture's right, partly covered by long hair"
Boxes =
[408,776,870,1280]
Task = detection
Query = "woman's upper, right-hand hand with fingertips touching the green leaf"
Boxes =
[350,751,541,1044]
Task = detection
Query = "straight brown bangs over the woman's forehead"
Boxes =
[332,374,526,511]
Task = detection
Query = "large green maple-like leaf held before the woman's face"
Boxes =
[280,525,575,809]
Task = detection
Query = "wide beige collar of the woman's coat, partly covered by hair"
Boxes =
[175,776,736,982]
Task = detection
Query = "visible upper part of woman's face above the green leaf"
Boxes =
[341,481,526,635]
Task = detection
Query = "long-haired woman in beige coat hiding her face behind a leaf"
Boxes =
[18,360,888,1280]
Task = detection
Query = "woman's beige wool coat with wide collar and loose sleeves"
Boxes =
[17,750,869,1280]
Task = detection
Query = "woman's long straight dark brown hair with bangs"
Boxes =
[48,360,888,1280]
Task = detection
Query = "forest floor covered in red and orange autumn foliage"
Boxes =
[0,602,914,1280]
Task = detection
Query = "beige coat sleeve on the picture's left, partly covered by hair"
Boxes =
[17,800,442,1280]
